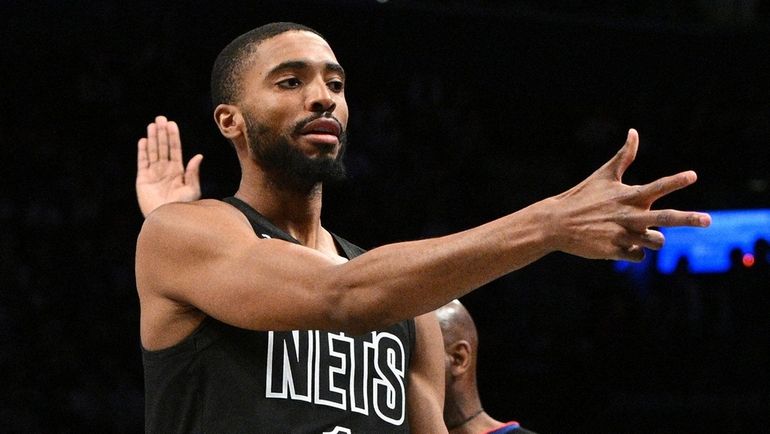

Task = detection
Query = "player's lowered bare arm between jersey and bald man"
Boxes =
[407,312,446,434]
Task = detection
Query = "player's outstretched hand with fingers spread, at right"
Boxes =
[548,129,711,261]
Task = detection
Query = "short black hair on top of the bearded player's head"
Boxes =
[211,22,326,107]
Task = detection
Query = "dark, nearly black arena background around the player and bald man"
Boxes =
[0,0,770,433]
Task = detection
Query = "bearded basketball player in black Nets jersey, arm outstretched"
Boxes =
[136,23,710,433]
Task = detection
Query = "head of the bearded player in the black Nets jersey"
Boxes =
[211,23,348,189]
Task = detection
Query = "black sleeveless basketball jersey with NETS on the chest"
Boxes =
[142,198,414,434]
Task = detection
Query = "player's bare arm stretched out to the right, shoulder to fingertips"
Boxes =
[136,130,710,340]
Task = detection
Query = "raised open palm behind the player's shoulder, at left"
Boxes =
[136,116,203,217]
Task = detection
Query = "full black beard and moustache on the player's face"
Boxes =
[244,112,347,191]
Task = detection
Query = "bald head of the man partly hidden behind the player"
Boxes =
[436,300,480,424]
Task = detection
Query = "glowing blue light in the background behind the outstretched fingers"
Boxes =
[615,209,770,275]
